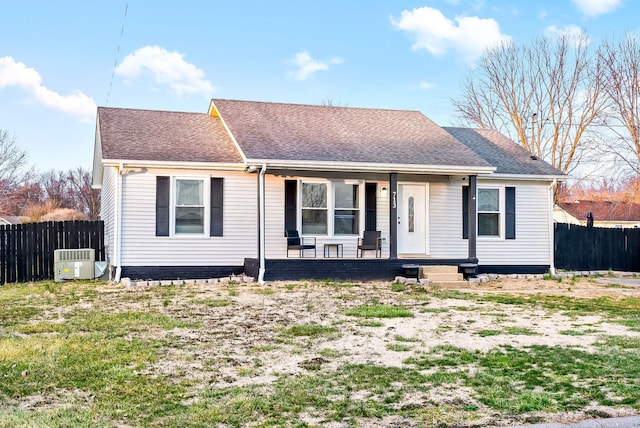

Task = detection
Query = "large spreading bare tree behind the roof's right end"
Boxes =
[453,36,606,173]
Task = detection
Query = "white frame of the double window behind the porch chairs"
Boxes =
[296,178,365,238]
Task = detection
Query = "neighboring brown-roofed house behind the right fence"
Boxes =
[553,199,640,228]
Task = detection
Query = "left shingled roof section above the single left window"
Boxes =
[98,107,242,163]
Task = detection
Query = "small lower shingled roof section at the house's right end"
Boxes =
[444,127,564,176]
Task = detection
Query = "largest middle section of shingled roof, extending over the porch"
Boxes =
[212,99,491,172]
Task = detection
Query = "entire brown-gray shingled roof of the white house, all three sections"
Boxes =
[98,99,562,176]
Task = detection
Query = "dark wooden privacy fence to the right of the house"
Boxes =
[555,223,640,272]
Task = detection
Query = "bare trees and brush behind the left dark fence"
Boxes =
[0,129,100,222]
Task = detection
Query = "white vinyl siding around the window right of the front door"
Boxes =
[429,180,551,265]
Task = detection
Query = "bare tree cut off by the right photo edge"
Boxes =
[600,34,640,175]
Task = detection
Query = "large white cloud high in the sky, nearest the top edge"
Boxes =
[391,6,511,62]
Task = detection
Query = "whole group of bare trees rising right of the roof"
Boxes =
[453,33,640,194]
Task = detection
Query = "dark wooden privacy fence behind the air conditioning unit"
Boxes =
[0,221,105,284]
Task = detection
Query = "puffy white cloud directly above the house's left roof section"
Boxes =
[116,46,216,96]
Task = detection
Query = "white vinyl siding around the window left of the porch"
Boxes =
[122,170,258,266]
